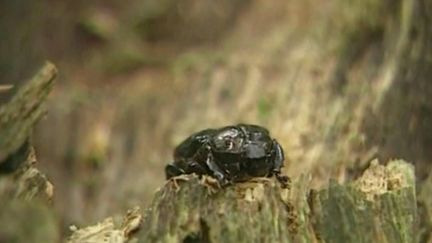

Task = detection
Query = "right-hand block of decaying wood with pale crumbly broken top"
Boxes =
[314,161,417,242]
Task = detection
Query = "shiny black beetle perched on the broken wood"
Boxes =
[165,124,288,187]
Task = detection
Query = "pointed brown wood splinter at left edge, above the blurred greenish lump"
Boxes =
[0,63,57,201]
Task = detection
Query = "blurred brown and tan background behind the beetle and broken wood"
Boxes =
[0,0,432,235]
